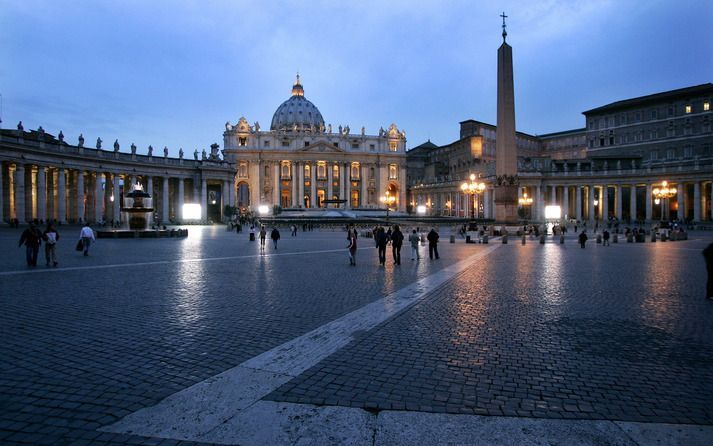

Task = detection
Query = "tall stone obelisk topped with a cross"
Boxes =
[495,12,518,224]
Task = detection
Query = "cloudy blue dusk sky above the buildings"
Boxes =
[0,0,713,156]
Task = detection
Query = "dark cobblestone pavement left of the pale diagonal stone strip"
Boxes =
[0,226,475,445]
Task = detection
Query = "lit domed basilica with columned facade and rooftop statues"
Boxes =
[223,76,406,213]
